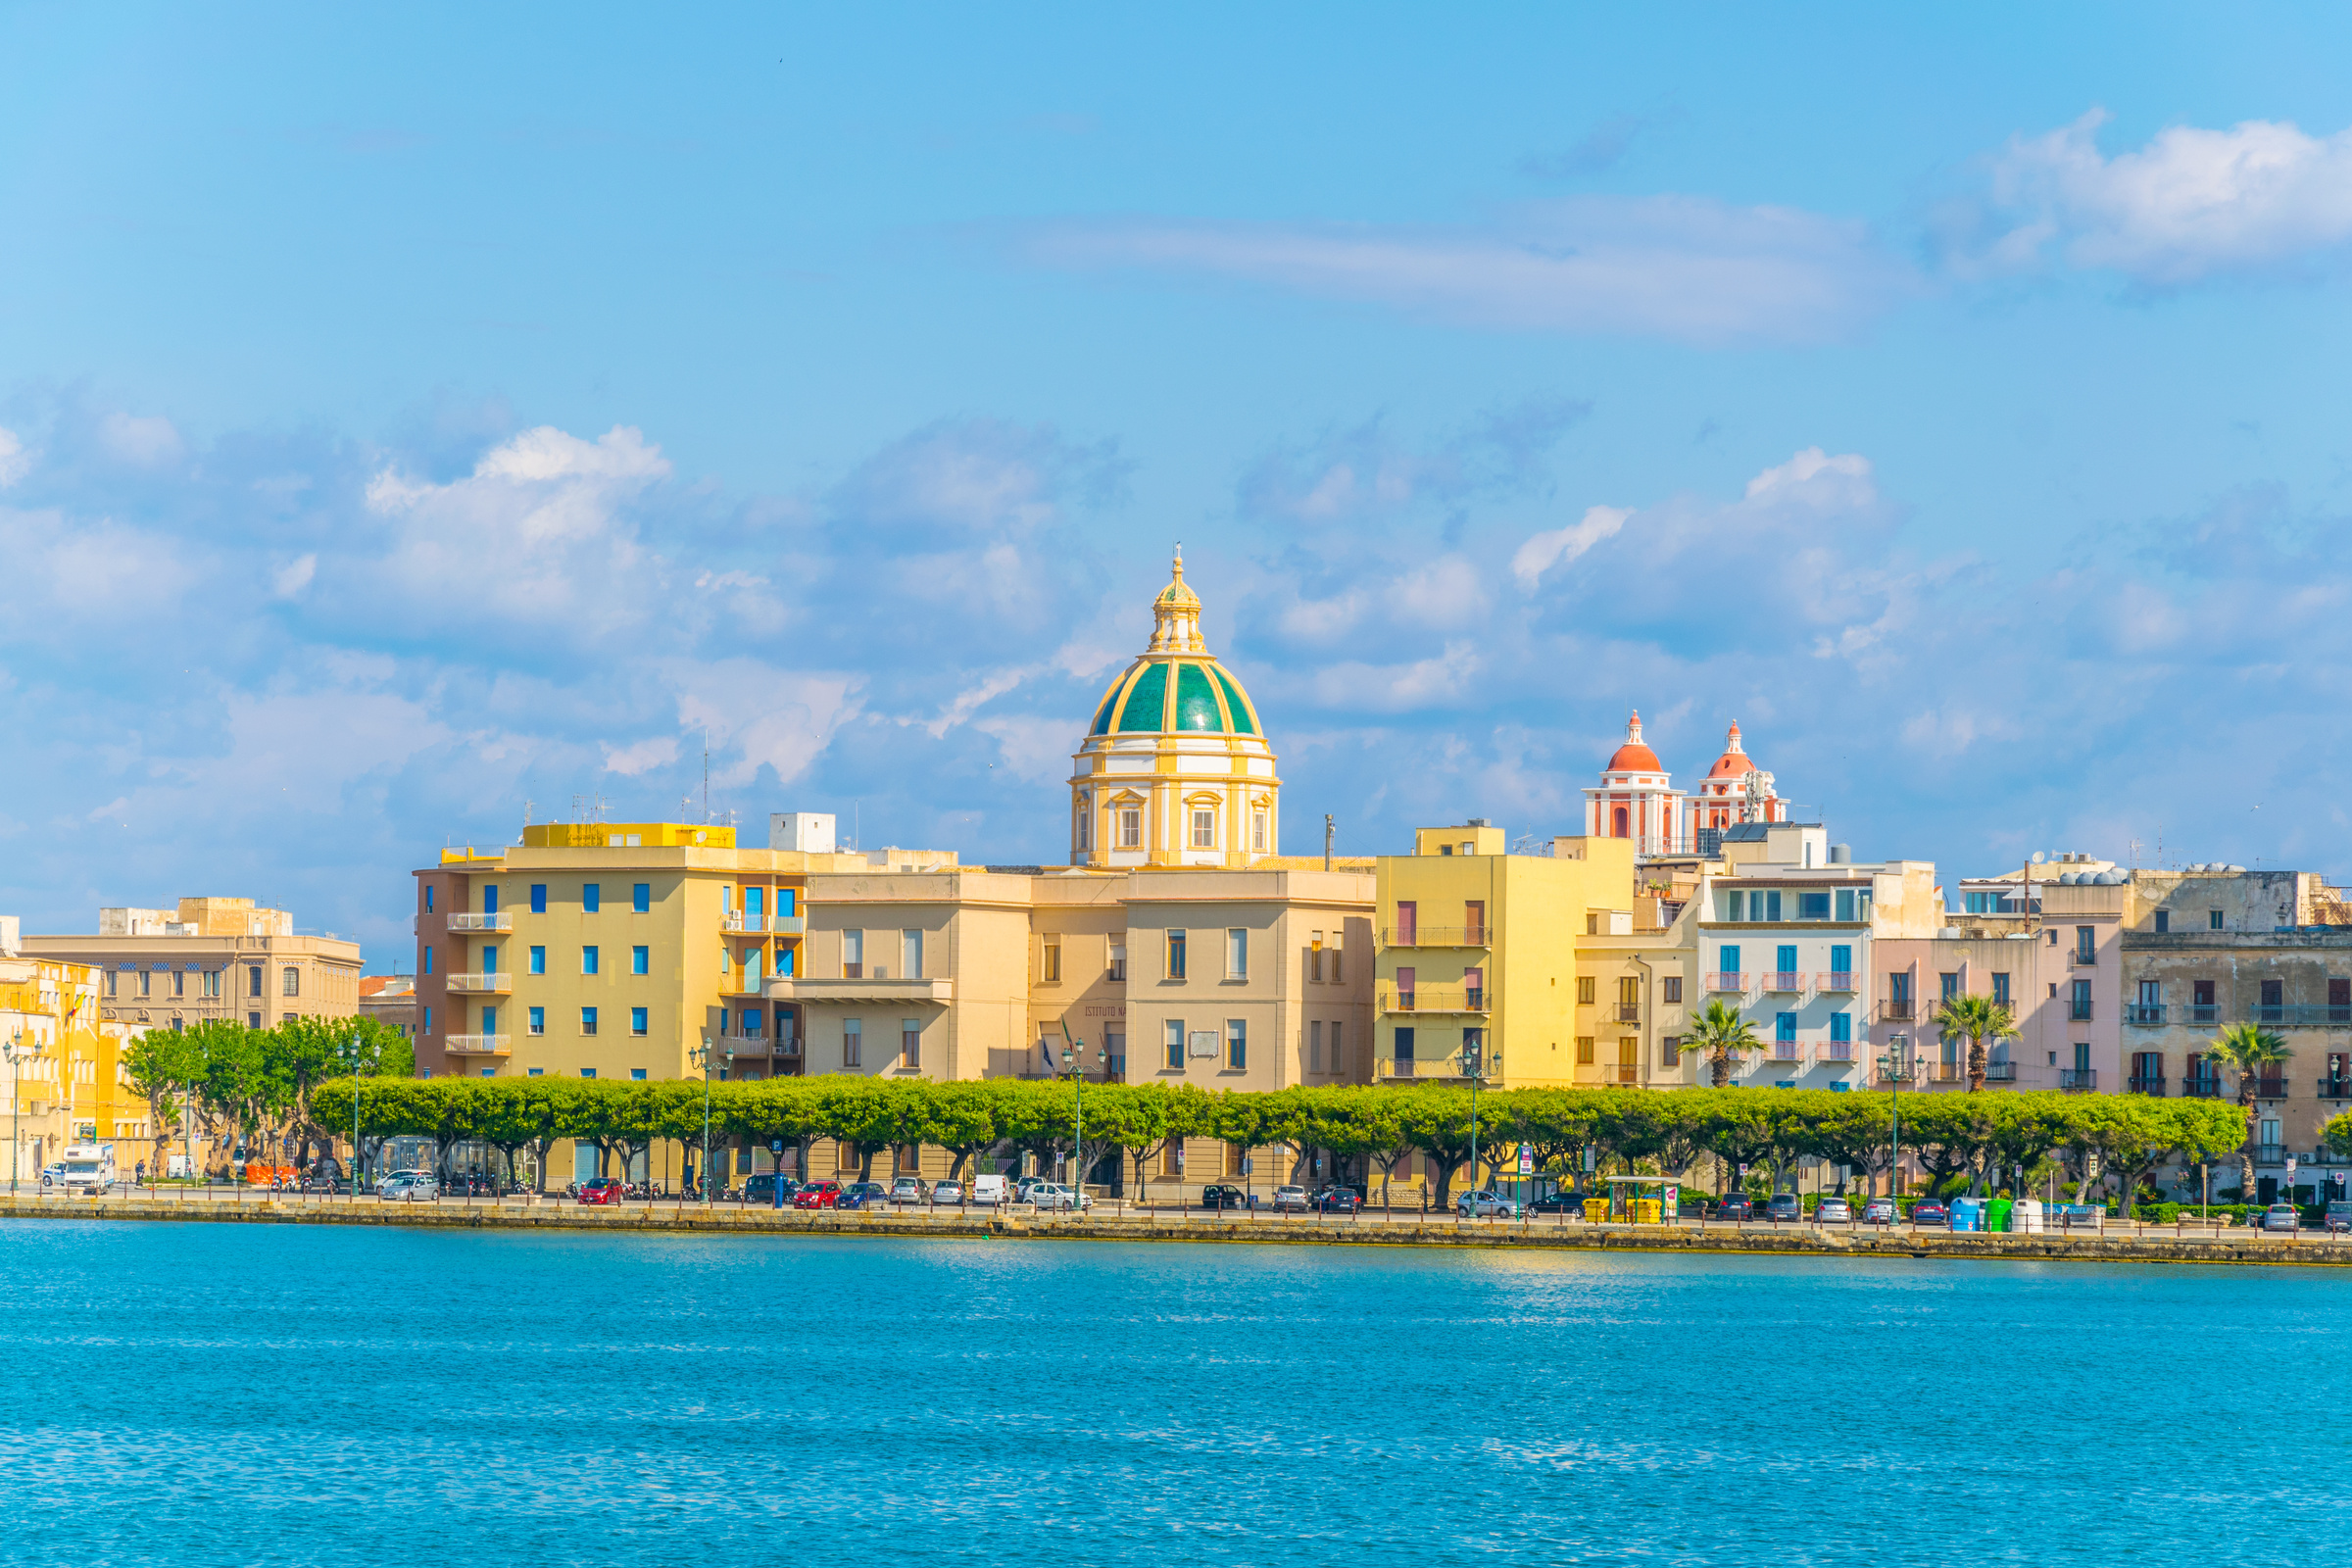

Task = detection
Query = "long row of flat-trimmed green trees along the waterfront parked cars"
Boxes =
[311,1074,2314,1206]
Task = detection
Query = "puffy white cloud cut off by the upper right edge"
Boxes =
[1954,111,2352,287]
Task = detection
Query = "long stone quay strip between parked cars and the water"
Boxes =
[0,1187,2352,1267]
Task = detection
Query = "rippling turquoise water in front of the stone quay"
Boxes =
[0,1222,2352,1568]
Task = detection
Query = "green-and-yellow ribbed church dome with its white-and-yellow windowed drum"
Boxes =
[1070,546,1282,867]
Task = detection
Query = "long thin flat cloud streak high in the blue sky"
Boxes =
[1030,195,1910,343]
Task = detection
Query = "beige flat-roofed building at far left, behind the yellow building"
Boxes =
[24,898,360,1030]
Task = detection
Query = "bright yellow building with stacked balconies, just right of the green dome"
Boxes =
[1374,820,1633,1089]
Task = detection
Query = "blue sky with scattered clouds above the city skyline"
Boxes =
[0,5,2352,968]
